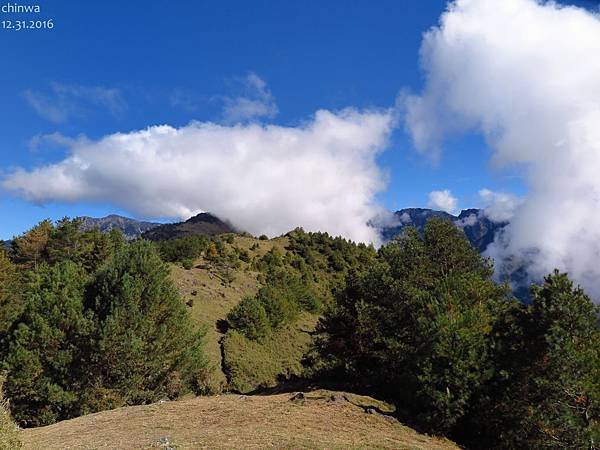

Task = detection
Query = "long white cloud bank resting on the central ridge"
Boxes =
[2,109,392,243]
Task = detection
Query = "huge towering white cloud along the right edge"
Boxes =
[406,0,600,298]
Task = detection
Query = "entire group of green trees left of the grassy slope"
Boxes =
[0,219,207,426]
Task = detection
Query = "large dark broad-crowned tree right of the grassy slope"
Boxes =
[319,219,507,432]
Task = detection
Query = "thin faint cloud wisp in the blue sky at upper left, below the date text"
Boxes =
[23,83,127,123]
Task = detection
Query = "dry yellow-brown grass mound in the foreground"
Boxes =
[22,391,458,450]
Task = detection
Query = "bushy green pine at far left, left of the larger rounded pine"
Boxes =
[2,261,93,426]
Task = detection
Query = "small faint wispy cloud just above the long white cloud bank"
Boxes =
[223,72,279,123]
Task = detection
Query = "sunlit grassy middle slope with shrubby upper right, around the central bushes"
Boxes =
[166,230,372,393]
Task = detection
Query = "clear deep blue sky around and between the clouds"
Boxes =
[0,0,589,239]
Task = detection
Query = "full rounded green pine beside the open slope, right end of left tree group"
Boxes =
[83,241,207,409]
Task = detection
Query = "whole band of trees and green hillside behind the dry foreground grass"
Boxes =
[0,219,600,449]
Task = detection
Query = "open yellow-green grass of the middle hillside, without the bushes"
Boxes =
[166,235,352,393]
